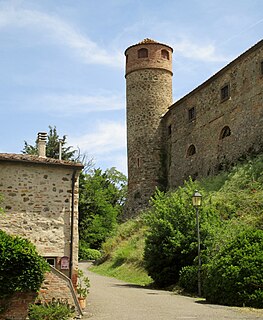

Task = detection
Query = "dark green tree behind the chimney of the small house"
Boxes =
[22,126,76,161]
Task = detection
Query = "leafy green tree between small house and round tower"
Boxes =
[79,168,126,249]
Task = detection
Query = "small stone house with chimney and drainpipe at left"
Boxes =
[0,132,83,318]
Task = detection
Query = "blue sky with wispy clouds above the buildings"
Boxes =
[0,0,263,173]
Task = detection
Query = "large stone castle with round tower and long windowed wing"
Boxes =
[125,39,263,214]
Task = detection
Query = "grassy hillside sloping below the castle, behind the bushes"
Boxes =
[93,156,263,285]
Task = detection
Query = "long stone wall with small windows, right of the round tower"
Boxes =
[164,42,263,188]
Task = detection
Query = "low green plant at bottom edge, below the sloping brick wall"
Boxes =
[28,299,75,320]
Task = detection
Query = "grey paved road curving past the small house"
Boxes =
[80,263,263,320]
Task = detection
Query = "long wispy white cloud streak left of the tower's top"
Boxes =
[0,5,123,68]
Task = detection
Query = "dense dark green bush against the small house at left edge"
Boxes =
[0,230,49,298]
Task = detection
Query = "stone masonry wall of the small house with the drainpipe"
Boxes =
[0,161,78,284]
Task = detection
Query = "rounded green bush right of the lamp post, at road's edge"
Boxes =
[205,230,263,308]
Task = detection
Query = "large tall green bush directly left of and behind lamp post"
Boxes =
[144,181,218,287]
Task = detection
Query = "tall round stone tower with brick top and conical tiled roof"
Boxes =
[125,39,173,216]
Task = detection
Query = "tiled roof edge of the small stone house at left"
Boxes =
[0,153,83,170]
